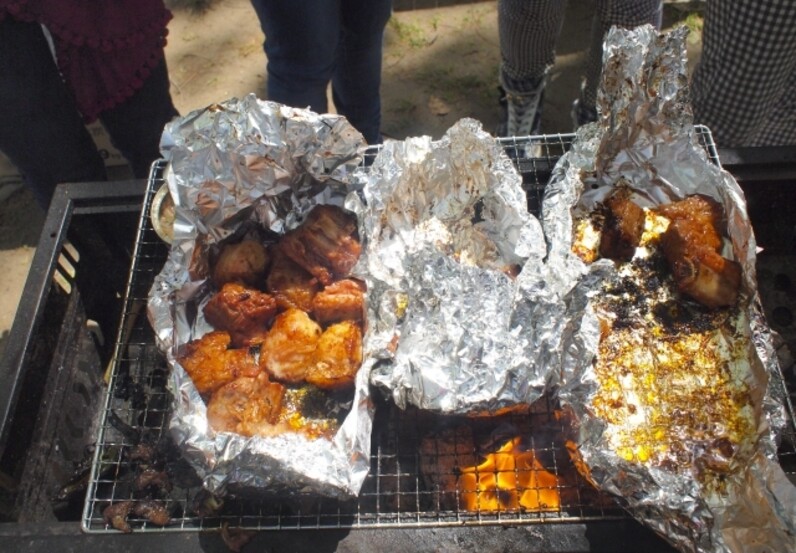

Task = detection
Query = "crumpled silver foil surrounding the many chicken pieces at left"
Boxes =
[148,95,373,497]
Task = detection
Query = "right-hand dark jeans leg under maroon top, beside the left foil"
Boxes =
[99,59,178,178]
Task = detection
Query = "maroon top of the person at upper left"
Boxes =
[0,0,172,122]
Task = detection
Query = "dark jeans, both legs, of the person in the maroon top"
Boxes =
[0,18,177,210]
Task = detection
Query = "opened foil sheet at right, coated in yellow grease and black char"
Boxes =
[543,27,796,552]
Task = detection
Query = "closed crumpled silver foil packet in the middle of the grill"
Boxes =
[350,119,563,416]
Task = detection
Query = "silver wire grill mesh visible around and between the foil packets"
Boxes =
[82,127,796,533]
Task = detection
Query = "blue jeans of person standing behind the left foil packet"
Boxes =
[252,0,392,144]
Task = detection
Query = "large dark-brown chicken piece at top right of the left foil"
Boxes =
[280,205,362,286]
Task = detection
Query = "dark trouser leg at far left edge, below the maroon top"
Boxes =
[0,19,106,209]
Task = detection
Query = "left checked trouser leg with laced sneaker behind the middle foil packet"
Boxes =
[498,0,566,136]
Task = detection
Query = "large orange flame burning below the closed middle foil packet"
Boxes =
[458,437,561,511]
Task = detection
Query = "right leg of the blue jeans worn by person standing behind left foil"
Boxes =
[332,0,392,144]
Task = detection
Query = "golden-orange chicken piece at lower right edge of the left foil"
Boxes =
[307,321,362,390]
